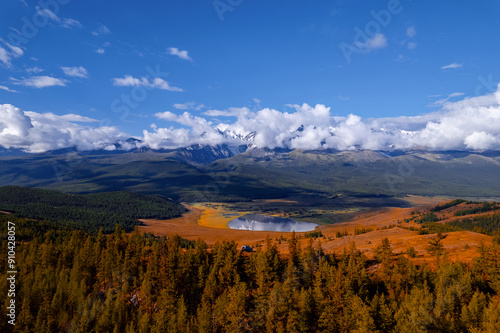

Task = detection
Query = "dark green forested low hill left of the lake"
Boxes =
[0,186,185,233]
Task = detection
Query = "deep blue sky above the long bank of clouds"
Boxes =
[0,0,500,152]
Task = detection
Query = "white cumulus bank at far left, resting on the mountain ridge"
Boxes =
[0,104,128,153]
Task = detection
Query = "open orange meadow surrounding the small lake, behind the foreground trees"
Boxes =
[138,196,494,263]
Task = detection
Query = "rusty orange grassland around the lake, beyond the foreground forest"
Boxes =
[138,197,492,262]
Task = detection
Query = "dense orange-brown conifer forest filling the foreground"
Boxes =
[0,215,500,333]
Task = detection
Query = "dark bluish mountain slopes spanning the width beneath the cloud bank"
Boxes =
[0,148,500,201]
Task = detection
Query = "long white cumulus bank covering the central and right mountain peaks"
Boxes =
[143,83,500,150]
